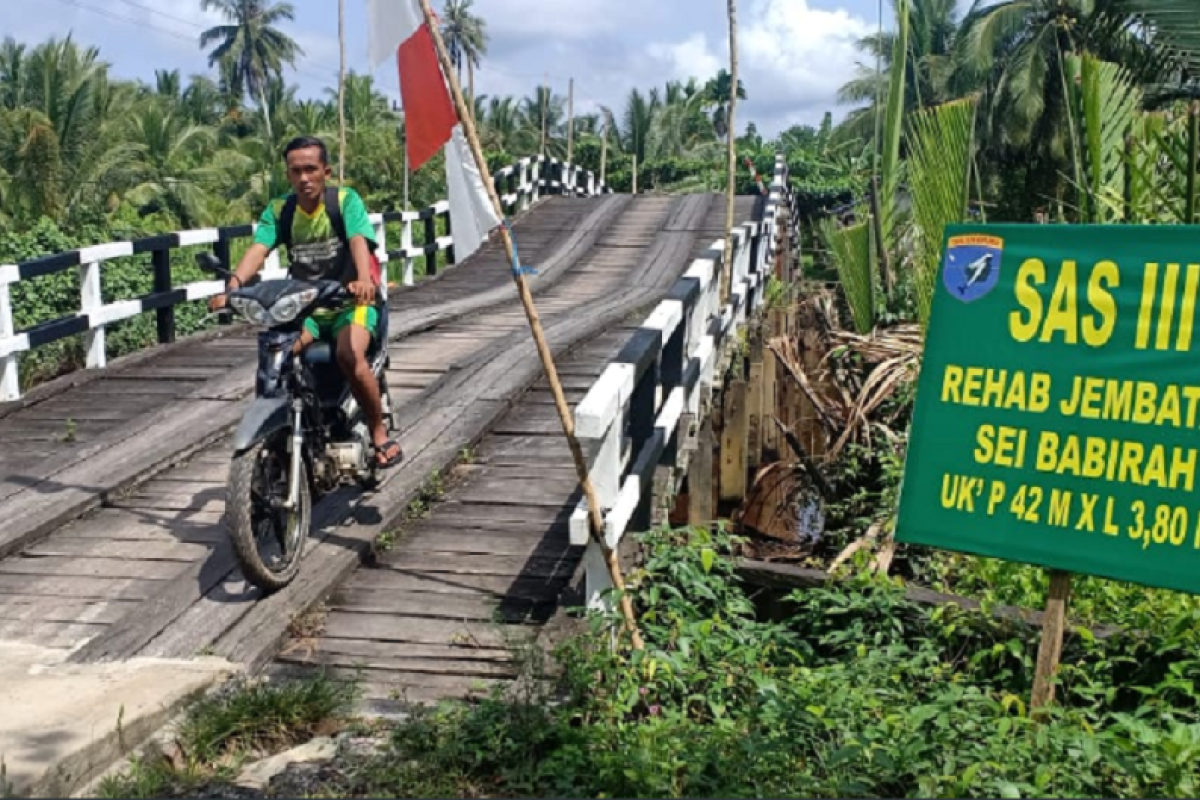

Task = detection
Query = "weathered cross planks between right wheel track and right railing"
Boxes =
[269,196,749,715]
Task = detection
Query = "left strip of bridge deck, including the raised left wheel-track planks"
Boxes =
[0,196,629,566]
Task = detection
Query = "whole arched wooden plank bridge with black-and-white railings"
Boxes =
[0,153,791,711]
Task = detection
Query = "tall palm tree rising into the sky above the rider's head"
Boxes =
[200,0,304,138]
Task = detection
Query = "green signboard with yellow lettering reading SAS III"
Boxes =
[896,224,1200,594]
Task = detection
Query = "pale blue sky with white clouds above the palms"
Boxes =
[0,0,892,136]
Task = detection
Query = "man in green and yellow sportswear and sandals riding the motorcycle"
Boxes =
[209,137,403,469]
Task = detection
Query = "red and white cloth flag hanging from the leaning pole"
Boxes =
[367,0,500,259]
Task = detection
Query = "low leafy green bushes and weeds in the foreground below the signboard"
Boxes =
[96,529,1200,798]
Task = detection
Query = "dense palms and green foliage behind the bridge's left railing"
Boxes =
[0,0,828,389]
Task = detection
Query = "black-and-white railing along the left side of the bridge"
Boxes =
[0,156,611,402]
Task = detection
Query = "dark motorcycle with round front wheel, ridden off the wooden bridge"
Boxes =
[197,253,396,591]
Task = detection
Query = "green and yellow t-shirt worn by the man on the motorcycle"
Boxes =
[254,187,374,283]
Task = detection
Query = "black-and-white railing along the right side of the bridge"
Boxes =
[570,156,791,608]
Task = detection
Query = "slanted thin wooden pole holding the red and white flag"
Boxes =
[420,0,644,650]
